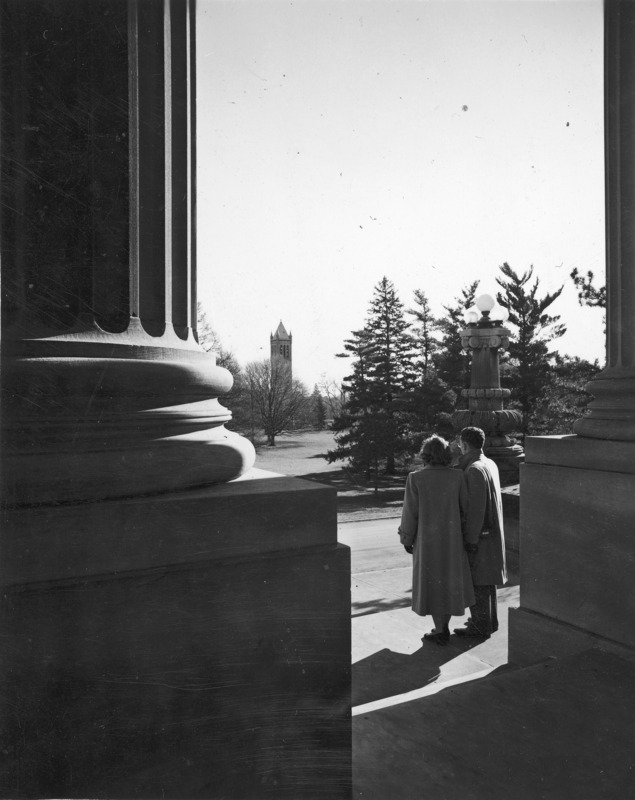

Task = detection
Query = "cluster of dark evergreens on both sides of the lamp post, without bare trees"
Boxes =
[328,263,599,480]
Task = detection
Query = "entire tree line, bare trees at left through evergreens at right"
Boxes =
[198,263,603,468]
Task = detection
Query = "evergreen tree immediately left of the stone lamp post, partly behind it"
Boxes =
[434,281,479,403]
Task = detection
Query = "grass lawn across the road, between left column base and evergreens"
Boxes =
[255,431,406,522]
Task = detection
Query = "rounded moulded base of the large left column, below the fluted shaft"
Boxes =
[2,340,256,505]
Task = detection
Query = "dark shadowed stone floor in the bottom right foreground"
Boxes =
[353,650,635,800]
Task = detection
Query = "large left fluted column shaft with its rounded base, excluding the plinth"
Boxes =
[2,0,254,504]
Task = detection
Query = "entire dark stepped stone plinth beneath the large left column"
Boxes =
[0,478,351,800]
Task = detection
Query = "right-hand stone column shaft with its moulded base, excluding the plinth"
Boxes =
[574,0,635,442]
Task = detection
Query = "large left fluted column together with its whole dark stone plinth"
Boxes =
[0,0,351,800]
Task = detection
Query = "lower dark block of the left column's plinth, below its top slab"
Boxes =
[0,523,351,800]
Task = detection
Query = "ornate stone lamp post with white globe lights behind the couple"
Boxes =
[452,294,524,477]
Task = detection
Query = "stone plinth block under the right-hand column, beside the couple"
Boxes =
[510,437,635,664]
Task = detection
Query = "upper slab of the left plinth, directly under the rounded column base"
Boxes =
[0,476,337,586]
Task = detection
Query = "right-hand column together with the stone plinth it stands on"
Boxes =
[509,0,635,664]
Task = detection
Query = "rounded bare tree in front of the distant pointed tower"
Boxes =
[244,358,308,446]
